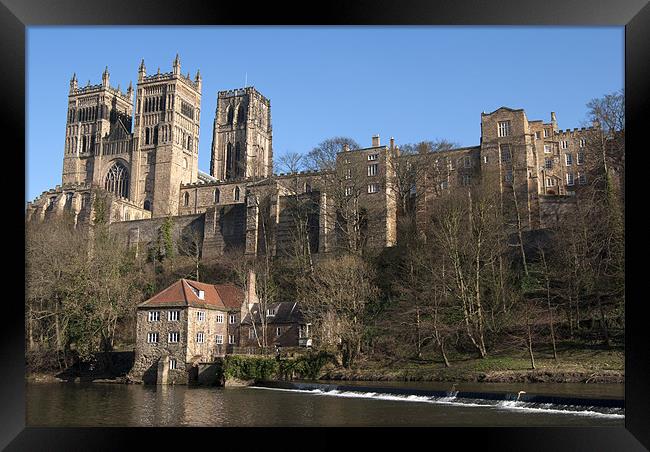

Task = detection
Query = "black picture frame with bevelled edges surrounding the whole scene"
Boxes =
[0,0,650,451]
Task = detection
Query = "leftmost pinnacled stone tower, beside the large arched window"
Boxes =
[62,67,133,192]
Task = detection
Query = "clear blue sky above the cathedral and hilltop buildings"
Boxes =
[25,26,624,201]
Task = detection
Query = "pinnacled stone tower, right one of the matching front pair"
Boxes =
[132,55,201,217]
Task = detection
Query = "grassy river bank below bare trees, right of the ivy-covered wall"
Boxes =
[321,345,625,383]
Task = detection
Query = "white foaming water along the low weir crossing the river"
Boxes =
[251,386,625,418]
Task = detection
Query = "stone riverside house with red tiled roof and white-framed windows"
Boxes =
[131,279,246,383]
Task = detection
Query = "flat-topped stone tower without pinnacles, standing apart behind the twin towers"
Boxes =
[210,86,273,180]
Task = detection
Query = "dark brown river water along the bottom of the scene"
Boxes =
[26,382,624,426]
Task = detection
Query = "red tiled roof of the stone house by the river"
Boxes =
[138,279,244,310]
